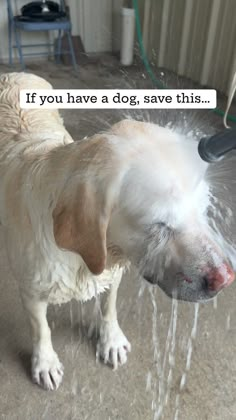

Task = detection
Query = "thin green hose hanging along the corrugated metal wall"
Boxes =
[133,0,236,123]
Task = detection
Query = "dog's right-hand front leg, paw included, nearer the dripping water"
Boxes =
[98,273,131,369]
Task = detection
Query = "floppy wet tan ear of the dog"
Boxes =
[53,181,111,274]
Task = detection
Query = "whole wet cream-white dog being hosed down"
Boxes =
[0,73,234,389]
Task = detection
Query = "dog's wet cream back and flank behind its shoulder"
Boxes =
[0,73,73,227]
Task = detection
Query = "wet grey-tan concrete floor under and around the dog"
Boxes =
[0,59,236,420]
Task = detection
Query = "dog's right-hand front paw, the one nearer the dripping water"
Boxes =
[97,320,131,370]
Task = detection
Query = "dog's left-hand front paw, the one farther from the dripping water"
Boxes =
[32,350,63,391]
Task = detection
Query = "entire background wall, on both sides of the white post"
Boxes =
[0,0,236,93]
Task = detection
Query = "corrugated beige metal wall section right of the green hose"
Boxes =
[139,0,236,93]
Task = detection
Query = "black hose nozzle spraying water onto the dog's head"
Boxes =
[198,128,236,163]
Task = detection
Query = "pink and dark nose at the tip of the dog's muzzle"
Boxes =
[204,264,235,292]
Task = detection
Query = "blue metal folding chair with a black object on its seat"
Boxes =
[7,0,77,70]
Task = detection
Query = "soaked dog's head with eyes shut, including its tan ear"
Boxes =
[53,121,234,301]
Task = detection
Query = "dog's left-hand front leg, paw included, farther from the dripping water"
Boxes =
[23,296,63,390]
